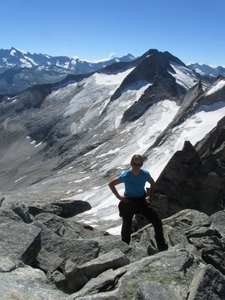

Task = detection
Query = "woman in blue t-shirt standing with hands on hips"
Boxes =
[109,154,168,251]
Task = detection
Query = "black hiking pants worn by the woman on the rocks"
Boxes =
[119,196,167,251]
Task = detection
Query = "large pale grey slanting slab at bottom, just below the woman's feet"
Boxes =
[72,251,202,300]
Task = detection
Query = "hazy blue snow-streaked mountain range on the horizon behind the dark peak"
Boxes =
[0,47,225,95]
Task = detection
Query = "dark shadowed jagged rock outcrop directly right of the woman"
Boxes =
[152,118,225,217]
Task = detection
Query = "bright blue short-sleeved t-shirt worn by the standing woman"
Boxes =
[118,169,151,198]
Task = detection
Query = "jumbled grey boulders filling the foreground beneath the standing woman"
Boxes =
[0,195,225,300]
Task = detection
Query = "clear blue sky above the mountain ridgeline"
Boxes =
[0,0,225,66]
